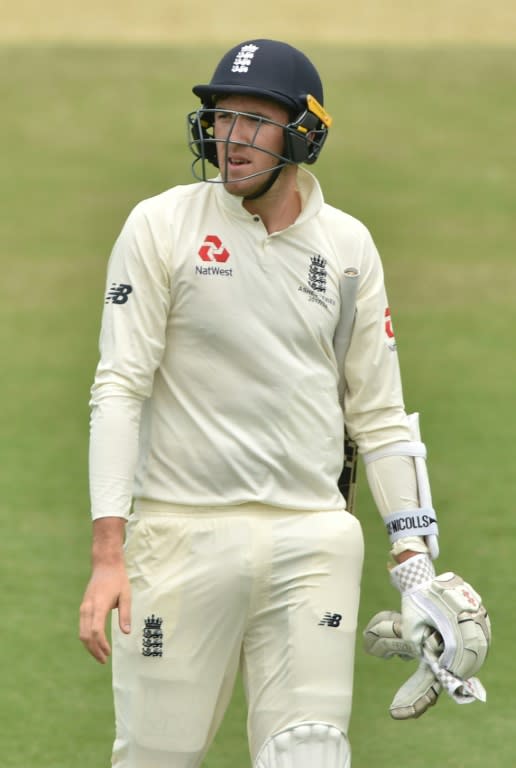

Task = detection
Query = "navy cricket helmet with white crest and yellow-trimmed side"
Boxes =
[188,39,332,180]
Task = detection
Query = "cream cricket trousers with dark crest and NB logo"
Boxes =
[112,502,363,768]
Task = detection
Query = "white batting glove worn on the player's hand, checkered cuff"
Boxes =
[391,555,491,703]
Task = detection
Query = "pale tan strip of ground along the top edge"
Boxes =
[0,0,516,44]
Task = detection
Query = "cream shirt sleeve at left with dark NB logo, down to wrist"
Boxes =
[90,204,170,519]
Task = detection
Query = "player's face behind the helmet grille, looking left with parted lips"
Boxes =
[214,95,289,196]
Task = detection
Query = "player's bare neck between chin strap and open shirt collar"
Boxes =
[242,166,301,234]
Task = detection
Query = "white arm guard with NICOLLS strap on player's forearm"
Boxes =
[363,413,439,560]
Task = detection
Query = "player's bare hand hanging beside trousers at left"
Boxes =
[79,560,131,664]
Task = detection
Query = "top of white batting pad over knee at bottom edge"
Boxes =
[254,723,351,768]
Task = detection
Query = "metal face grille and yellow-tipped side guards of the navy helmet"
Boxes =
[187,96,331,183]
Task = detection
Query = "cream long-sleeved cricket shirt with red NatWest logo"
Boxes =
[90,169,410,518]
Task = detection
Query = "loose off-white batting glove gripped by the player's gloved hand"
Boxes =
[363,611,443,720]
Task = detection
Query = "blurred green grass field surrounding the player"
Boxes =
[0,40,516,768]
